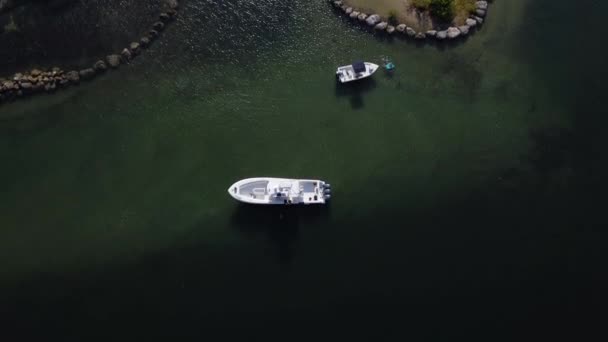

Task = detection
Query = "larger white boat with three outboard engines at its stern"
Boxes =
[228,177,331,205]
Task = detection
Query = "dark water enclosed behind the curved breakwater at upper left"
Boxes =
[0,0,163,76]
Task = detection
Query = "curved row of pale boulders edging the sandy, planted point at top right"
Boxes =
[328,0,491,41]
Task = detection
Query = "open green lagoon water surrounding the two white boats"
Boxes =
[0,0,606,341]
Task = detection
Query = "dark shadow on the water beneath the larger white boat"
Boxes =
[232,203,331,263]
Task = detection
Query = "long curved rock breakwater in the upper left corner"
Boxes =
[0,0,179,104]
